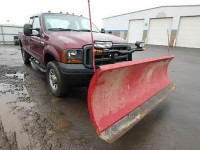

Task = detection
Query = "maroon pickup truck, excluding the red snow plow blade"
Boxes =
[19,13,144,96]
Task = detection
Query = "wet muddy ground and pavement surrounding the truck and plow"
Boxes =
[0,45,200,150]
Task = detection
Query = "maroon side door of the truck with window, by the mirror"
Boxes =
[29,16,45,63]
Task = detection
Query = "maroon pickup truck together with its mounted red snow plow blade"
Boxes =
[19,13,175,143]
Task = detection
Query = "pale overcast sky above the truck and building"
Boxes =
[0,0,200,28]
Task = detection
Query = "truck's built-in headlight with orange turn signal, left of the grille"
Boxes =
[62,49,83,63]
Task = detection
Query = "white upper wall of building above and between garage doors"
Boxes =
[103,5,200,30]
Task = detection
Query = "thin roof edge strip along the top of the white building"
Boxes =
[103,5,200,19]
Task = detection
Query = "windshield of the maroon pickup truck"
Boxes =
[44,14,99,32]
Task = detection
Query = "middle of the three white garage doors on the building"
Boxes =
[147,18,172,45]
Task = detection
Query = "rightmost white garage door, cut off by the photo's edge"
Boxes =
[176,17,200,48]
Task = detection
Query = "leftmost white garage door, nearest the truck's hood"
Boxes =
[128,20,144,43]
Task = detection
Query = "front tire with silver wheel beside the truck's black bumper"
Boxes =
[46,61,68,97]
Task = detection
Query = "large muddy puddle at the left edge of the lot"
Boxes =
[0,73,34,150]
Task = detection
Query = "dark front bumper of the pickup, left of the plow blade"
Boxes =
[58,62,94,87]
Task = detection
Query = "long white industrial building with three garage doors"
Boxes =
[103,5,200,48]
